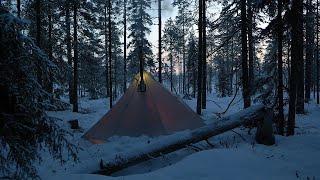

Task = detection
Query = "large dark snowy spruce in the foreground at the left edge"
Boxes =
[0,5,76,179]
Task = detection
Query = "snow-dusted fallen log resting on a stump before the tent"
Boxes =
[96,105,274,175]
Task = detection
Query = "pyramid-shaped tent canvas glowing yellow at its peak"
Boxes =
[83,72,204,143]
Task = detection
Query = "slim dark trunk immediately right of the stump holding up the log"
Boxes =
[277,0,284,135]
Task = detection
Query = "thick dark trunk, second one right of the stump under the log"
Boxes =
[287,0,304,136]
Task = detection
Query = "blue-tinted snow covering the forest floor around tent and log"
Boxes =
[38,96,320,180]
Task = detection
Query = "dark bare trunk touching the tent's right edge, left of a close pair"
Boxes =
[197,0,203,115]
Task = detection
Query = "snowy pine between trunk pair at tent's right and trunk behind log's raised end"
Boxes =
[207,1,241,97]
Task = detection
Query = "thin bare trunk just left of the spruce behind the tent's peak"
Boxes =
[123,0,127,93]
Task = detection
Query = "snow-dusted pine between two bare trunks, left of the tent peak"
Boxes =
[79,2,105,99]
